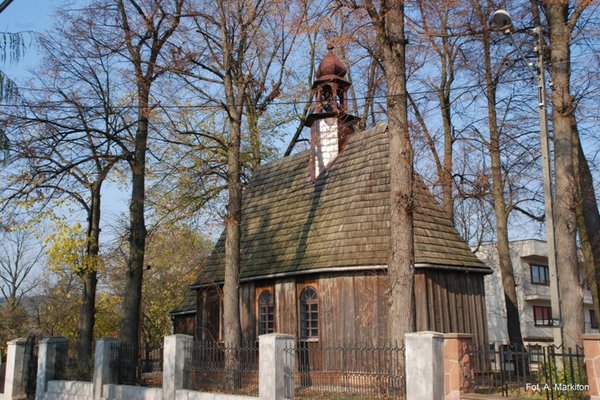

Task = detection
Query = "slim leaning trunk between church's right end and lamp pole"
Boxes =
[478,9,523,346]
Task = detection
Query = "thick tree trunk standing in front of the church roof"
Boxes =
[371,2,415,344]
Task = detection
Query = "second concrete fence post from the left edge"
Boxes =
[35,336,69,400]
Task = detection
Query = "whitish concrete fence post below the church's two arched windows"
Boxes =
[258,333,296,400]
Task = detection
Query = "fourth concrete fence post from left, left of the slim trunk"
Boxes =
[163,334,194,400]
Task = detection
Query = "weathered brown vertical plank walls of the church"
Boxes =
[196,269,487,346]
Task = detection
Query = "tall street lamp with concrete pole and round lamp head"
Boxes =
[492,10,563,346]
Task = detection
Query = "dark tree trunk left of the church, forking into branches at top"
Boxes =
[116,0,184,380]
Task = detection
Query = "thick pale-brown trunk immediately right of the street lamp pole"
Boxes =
[543,1,584,348]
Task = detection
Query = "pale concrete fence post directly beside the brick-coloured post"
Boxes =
[404,331,444,400]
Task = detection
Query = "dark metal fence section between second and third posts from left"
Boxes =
[55,340,96,382]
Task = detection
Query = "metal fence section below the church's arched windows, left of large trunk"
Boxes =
[286,341,406,400]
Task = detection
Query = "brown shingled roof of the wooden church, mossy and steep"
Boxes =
[192,125,489,287]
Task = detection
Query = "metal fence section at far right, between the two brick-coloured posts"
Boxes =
[468,345,587,400]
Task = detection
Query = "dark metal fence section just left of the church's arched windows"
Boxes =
[184,341,258,396]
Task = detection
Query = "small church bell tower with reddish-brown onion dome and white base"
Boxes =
[305,45,358,181]
